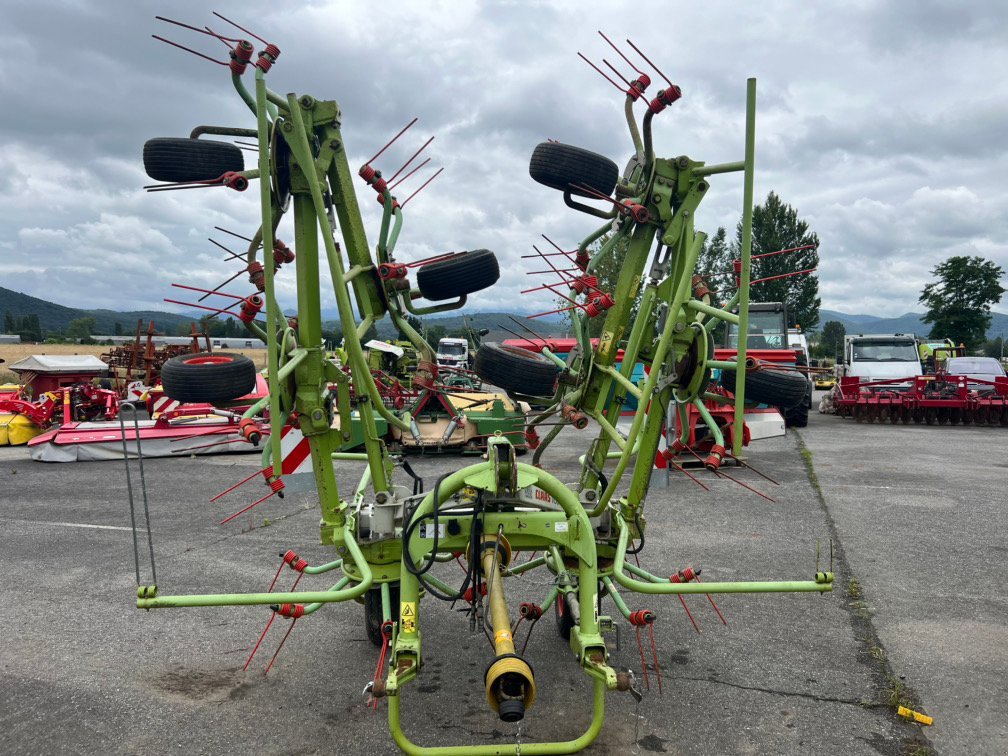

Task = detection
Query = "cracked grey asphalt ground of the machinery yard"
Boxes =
[0,395,1008,754]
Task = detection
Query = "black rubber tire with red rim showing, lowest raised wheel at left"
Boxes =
[161,352,256,404]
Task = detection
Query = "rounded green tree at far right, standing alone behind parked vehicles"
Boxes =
[918,256,1005,351]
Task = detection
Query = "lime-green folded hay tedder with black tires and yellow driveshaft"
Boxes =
[137,17,833,754]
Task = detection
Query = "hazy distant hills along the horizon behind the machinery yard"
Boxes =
[0,286,1008,340]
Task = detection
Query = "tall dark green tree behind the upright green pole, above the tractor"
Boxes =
[732,192,822,331]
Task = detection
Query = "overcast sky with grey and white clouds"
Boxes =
[0,0,1008,316]
